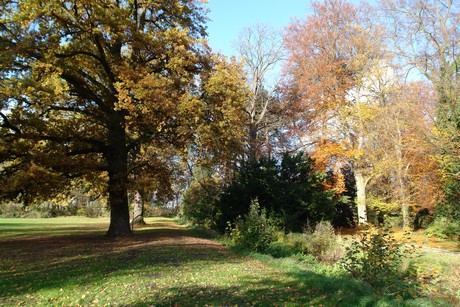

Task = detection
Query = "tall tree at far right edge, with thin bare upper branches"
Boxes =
[382,0,460,220]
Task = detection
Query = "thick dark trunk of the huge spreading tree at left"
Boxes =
[106,112,132,237]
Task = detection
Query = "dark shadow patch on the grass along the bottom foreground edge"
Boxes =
[137,272,399,306]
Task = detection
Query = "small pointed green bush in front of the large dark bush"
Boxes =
[228,199,277,252]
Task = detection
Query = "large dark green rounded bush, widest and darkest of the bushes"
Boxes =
[218,153,337,231]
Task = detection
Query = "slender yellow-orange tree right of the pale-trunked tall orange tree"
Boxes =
[370,78,438,228]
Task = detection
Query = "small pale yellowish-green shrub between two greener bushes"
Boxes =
[302,221,342,263]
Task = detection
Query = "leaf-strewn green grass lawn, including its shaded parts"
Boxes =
[0,218,449,306]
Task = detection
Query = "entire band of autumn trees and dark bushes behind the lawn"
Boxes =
[0,0,460,239]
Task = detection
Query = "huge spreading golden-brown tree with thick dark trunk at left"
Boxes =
[0,0,248,236]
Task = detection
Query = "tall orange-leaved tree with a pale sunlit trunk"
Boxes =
[285,0,385,224]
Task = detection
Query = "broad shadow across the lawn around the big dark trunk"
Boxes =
[0,223,232,303]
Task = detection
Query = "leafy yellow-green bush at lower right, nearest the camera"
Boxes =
[341,228,416,297]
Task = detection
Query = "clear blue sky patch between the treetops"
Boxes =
[207,0,311,56]
